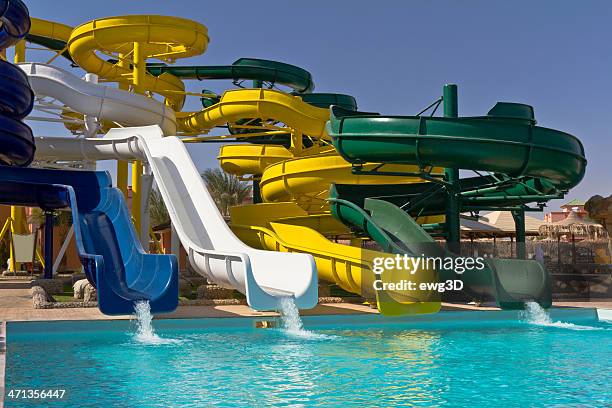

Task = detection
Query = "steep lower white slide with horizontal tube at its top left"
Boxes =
[36,126,318,310]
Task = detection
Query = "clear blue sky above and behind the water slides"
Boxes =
[20,0,612,215]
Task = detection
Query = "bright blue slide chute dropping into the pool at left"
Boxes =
[0,167,178,315]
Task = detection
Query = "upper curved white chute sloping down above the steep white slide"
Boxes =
[18,63,176,135]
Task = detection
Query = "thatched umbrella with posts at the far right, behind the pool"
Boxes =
[540,211,606,264]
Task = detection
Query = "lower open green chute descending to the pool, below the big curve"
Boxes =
[330,190,552,309]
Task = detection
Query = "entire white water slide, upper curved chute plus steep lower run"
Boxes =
[22,64,318,310]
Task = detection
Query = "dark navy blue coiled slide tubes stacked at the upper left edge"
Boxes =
[0,0,36,166]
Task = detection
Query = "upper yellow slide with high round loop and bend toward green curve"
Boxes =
[31,15,329,135]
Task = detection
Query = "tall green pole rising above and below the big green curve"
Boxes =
[443,84,461,252]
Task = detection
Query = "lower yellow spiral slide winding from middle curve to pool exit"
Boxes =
[218,110,440,315]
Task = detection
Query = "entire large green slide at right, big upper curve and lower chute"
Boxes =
[327,103,586,308]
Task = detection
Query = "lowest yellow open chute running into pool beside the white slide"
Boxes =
[231,203,440,316]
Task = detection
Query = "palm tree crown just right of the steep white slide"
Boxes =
[201,169,252,216]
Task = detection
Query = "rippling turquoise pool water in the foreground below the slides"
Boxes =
[6,310,612,407]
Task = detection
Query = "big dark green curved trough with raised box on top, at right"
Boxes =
[327,102,586,190]
